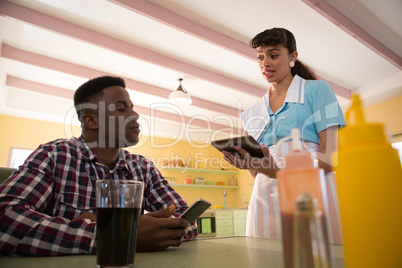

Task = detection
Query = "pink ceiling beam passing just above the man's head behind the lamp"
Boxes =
[1,44,241,118]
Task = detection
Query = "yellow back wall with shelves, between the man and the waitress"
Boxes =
[128,131,253,208]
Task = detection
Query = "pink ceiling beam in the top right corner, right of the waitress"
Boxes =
[302,0,402,70]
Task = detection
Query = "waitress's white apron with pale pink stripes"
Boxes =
[246,142,342,244]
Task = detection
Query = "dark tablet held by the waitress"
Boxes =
[211,136,264,158]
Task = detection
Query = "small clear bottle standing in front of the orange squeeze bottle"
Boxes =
[293,193,330,268]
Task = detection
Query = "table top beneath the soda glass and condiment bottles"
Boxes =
[0,237,344,268]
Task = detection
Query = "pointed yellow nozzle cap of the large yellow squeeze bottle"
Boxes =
[339,95,386,148]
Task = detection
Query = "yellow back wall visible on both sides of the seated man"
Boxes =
[0,115,253,208]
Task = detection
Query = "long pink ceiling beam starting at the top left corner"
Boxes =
[0,1,266,97]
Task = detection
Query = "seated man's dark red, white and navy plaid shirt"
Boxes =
[0,137,197,256]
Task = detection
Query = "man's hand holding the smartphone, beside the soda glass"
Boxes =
[137,205,190,251]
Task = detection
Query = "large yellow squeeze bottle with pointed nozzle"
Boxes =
[332,95,402,268]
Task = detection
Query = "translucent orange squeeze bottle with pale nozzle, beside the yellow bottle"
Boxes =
[277,129,330,268]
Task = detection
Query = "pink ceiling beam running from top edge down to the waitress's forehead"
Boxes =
[109,0,256,61]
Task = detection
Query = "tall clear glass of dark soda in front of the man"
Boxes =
[96,179,144,268]
